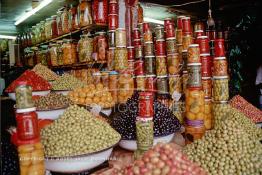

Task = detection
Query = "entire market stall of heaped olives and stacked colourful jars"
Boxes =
[1,0,262,175]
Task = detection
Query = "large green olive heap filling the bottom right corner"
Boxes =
[184,107,262,175]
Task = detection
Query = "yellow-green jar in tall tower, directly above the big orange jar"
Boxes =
[114,47,128,71]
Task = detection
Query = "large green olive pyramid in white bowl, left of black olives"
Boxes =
[41,105,121,157]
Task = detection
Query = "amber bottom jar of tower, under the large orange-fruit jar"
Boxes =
[185,120,206,144]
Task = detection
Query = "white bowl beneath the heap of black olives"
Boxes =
[119,133,174,151]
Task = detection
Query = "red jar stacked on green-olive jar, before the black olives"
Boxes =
[135,92,154,159]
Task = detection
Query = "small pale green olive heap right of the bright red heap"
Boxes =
[52,74,86,90]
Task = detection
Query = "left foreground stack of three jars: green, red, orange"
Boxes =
[15,82,45,175]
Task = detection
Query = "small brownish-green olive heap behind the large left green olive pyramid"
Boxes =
[35,92,72,110]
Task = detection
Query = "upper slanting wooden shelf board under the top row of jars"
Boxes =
[33,24,107,47]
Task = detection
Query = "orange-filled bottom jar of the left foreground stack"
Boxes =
[17,142,45,175]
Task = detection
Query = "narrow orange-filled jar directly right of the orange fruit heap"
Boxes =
[109,71,118,103]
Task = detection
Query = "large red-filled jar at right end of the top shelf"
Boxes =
[93,0,108,25]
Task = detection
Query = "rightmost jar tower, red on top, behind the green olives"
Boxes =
[213,39,229,126]
